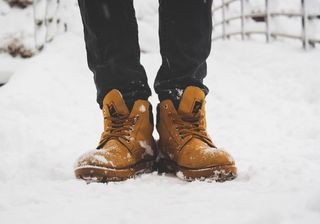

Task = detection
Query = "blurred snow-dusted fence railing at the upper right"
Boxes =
[212,0,320,49]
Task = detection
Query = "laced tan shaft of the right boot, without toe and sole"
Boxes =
[157,86,214,148]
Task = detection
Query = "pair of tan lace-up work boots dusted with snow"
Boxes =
[75,86,237,182]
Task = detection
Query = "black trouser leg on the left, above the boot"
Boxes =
[78,0,151,108]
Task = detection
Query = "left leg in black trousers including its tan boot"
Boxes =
[74,0,156,182]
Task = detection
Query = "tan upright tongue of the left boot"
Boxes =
[103,89,129,117]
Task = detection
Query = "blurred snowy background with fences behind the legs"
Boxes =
[0,0,320,85]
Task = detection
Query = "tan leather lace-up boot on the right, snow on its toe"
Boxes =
[157,86,237,181]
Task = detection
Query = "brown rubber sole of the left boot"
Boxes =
[74,161,154,183]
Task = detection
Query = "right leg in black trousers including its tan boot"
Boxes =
[155,0,237,181]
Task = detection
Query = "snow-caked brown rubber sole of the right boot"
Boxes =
[157,159,237,182]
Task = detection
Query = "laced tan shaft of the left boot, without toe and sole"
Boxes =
[98,90,153,154]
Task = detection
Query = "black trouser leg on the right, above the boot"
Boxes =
[154,0,212,107]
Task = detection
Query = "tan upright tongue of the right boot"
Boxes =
[178,86,205,115]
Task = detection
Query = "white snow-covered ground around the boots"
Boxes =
[0,0,320,224]
